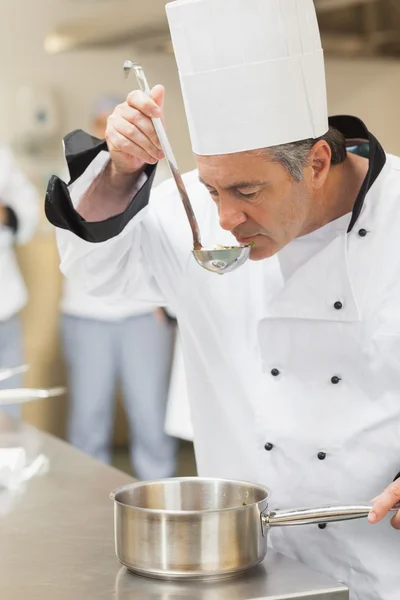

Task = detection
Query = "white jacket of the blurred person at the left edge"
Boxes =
[0,146,40,321]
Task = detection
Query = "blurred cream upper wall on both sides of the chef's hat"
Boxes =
[0,0,400,180]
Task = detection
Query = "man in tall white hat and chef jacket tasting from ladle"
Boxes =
[46,0,400,600]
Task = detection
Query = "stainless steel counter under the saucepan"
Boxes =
[0,428,349,600]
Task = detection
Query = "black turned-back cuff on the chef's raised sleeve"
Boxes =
[45,130,156,243]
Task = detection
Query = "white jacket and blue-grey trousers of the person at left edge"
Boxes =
[0,145,40,417]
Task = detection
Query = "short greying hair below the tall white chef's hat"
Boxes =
[263,127,346,181]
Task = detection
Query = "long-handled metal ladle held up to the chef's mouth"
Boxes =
[124,60,251,275]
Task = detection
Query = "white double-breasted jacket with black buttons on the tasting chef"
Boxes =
[46,119,400,600]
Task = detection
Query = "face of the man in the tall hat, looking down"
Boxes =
[196,142,330,260]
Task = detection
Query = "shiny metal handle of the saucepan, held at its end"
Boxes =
[261,504,400,528]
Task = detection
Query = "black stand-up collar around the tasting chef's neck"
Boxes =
[329,115,386,232]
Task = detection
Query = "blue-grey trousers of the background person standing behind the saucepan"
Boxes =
[62,314,177,480]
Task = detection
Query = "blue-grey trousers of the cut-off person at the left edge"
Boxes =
[0,315,24,418]
